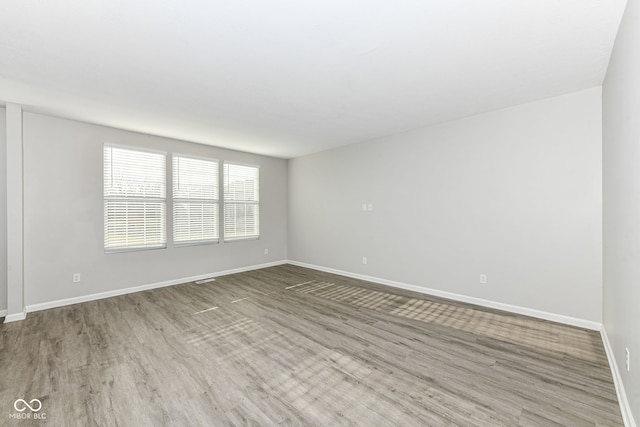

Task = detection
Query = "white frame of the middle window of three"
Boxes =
[171,152,221,247]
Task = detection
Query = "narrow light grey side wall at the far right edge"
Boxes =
[602,0,640,421]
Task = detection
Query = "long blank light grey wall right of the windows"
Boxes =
[288,88,602,322]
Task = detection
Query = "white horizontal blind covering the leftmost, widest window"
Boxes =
[104,145,167,250]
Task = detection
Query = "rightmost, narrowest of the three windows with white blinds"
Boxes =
[223,162,260,241]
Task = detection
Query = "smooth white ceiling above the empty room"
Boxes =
[0,0,626,158]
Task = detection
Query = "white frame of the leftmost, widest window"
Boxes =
[102,143,167,254]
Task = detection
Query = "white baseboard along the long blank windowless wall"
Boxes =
[288,260,602,331]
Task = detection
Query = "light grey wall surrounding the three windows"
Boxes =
[24,113,287,306]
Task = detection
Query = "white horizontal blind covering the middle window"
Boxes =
[173,155,219,244]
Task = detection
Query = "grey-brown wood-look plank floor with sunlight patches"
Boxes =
[0,265,622,426]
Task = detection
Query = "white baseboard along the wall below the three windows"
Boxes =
[24,261,287,316]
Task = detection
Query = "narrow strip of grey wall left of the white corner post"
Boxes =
[0,108,7,311]
